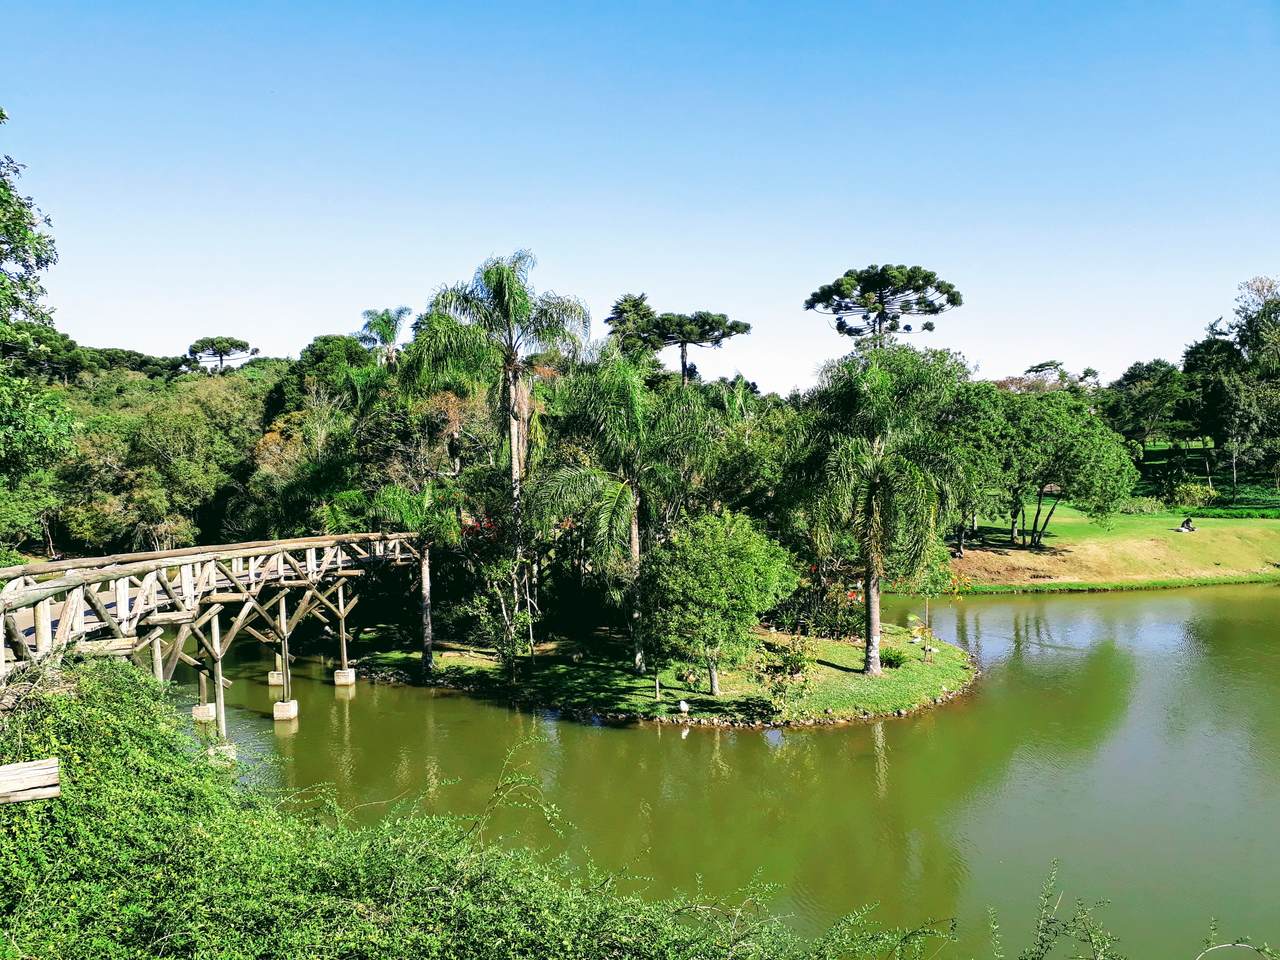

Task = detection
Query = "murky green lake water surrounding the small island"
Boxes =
[180,586,1280,957]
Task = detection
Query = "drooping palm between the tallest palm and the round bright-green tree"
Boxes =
[532,344,718,673]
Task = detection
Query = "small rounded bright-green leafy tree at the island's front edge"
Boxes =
[640,513,796,692]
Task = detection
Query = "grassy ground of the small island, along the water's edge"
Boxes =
[362,626,974,724]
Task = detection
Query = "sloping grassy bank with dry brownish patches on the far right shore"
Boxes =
[952,507,1280,593]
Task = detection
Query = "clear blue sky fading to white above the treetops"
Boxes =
[0,0,1280,389]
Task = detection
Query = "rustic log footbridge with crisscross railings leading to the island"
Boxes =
[0,534,419,736]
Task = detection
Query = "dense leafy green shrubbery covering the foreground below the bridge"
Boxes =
[0,660,932,960]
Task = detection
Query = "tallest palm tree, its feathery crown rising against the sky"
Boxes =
[430,250,590,596]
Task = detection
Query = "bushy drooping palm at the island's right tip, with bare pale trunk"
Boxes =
[808,344,961,676]
